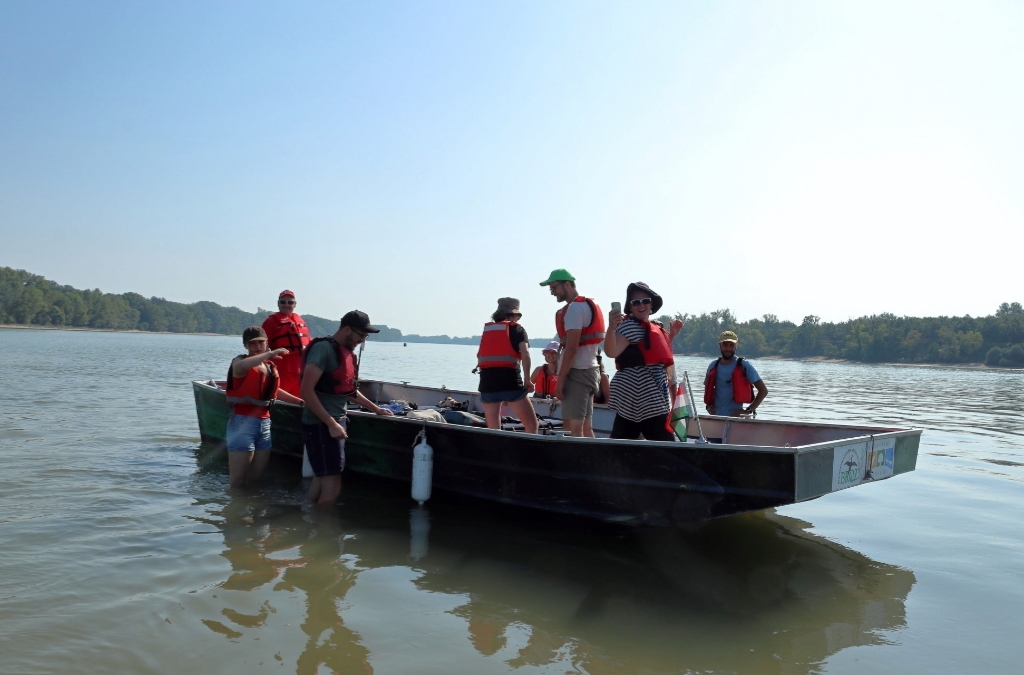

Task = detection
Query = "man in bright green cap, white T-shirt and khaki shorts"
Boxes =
[541,269,604,437]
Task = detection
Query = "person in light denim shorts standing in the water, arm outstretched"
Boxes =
[226,326,302,488]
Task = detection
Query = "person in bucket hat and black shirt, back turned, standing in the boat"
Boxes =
[474,298,538,433]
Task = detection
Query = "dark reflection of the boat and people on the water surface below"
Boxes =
[188,469,915,674]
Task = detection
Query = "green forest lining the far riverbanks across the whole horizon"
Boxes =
[0,267,1024,368]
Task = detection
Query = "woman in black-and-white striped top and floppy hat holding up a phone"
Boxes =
[604,282,683,441]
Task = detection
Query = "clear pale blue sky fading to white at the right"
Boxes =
[0,1,1024,336]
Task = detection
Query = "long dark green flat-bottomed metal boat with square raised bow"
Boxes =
[193,380,922,526]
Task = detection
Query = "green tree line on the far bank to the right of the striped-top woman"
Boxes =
[662,302,1024,368]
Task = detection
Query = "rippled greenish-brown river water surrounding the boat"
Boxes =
[0,330,1024,675]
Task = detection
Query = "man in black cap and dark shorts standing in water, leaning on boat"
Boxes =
[301,309,392,506]
